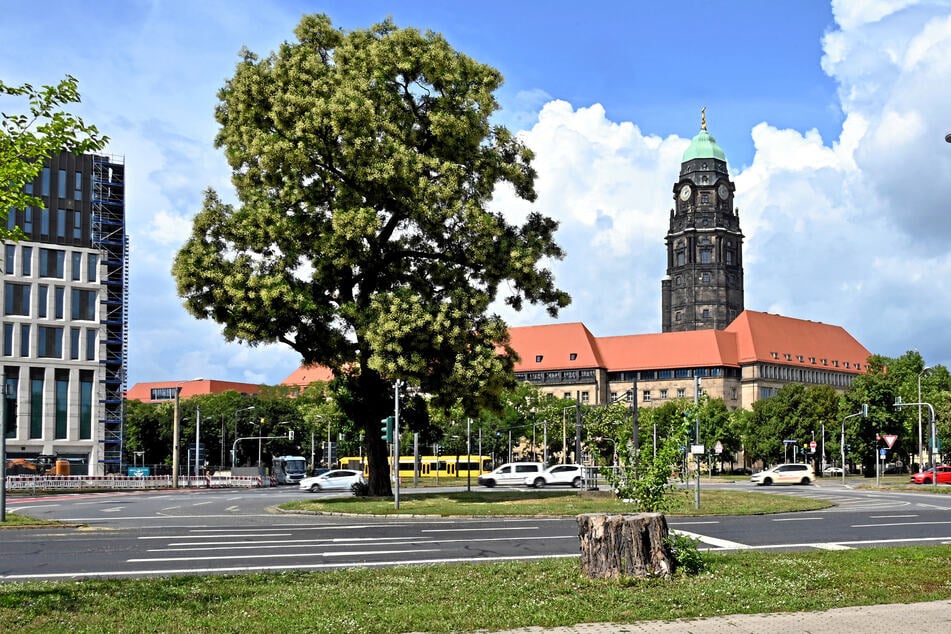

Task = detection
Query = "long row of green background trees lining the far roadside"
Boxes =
[125,352,951,473]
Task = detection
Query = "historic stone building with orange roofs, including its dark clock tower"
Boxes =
[510,112,869,409]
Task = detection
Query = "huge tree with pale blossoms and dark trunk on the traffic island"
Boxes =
[173,15,569,494]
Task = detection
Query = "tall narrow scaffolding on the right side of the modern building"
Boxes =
[92,155,129,473]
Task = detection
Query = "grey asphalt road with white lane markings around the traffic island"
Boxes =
[0,483,951,581]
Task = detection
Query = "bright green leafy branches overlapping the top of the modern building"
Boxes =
[0,75,109,240]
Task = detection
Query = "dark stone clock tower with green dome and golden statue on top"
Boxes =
[661,108,743,332]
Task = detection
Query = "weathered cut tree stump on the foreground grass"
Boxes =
[578,513,676,579]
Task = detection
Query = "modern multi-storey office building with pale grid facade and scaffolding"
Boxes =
[2,153,129,475]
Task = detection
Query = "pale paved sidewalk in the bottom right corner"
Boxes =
[497,600,951,634]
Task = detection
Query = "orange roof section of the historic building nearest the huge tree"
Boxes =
[509,322,604,372]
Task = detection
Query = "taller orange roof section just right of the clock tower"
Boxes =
[726,310,871,372]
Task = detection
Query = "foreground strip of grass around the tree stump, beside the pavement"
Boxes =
[0,546,951,634]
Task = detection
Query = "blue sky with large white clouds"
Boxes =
[0,0,951,385]
